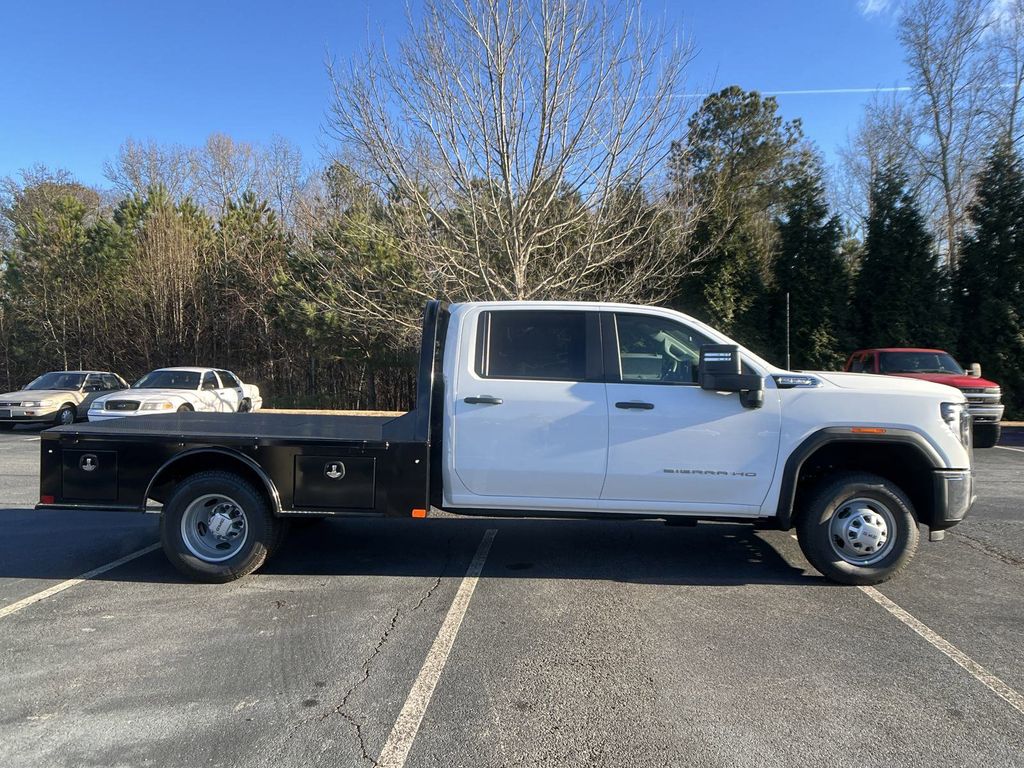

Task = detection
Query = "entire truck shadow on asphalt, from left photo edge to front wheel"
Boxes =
[0,509,829,589]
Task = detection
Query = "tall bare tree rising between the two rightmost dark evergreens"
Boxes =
[899,0,993,266]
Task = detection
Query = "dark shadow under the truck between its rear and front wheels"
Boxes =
[261,517,829,586]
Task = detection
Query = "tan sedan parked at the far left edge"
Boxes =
[0,371,128,429]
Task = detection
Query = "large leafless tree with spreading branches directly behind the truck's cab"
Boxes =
[319,0,693,335]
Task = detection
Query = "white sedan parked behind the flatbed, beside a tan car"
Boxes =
[89,368,263,421]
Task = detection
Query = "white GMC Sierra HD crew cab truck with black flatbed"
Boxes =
[37,301,975,585]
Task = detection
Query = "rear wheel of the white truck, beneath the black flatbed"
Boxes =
[160,471,284,584]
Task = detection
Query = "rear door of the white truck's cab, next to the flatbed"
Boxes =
[449,307,608,501]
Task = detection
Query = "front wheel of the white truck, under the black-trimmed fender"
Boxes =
[797,472,918,586]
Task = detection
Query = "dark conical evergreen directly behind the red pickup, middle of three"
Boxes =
[853,169,949,347]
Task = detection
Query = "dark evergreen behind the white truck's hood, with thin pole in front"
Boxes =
[766,159,850,370]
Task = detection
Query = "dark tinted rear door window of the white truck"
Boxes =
[476,309,589,381]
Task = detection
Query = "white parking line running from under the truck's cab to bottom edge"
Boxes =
[377,528,498,768]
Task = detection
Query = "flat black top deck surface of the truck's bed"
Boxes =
[44,411,414,442]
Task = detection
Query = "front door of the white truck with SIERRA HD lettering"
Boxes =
[601,312,780,514]
